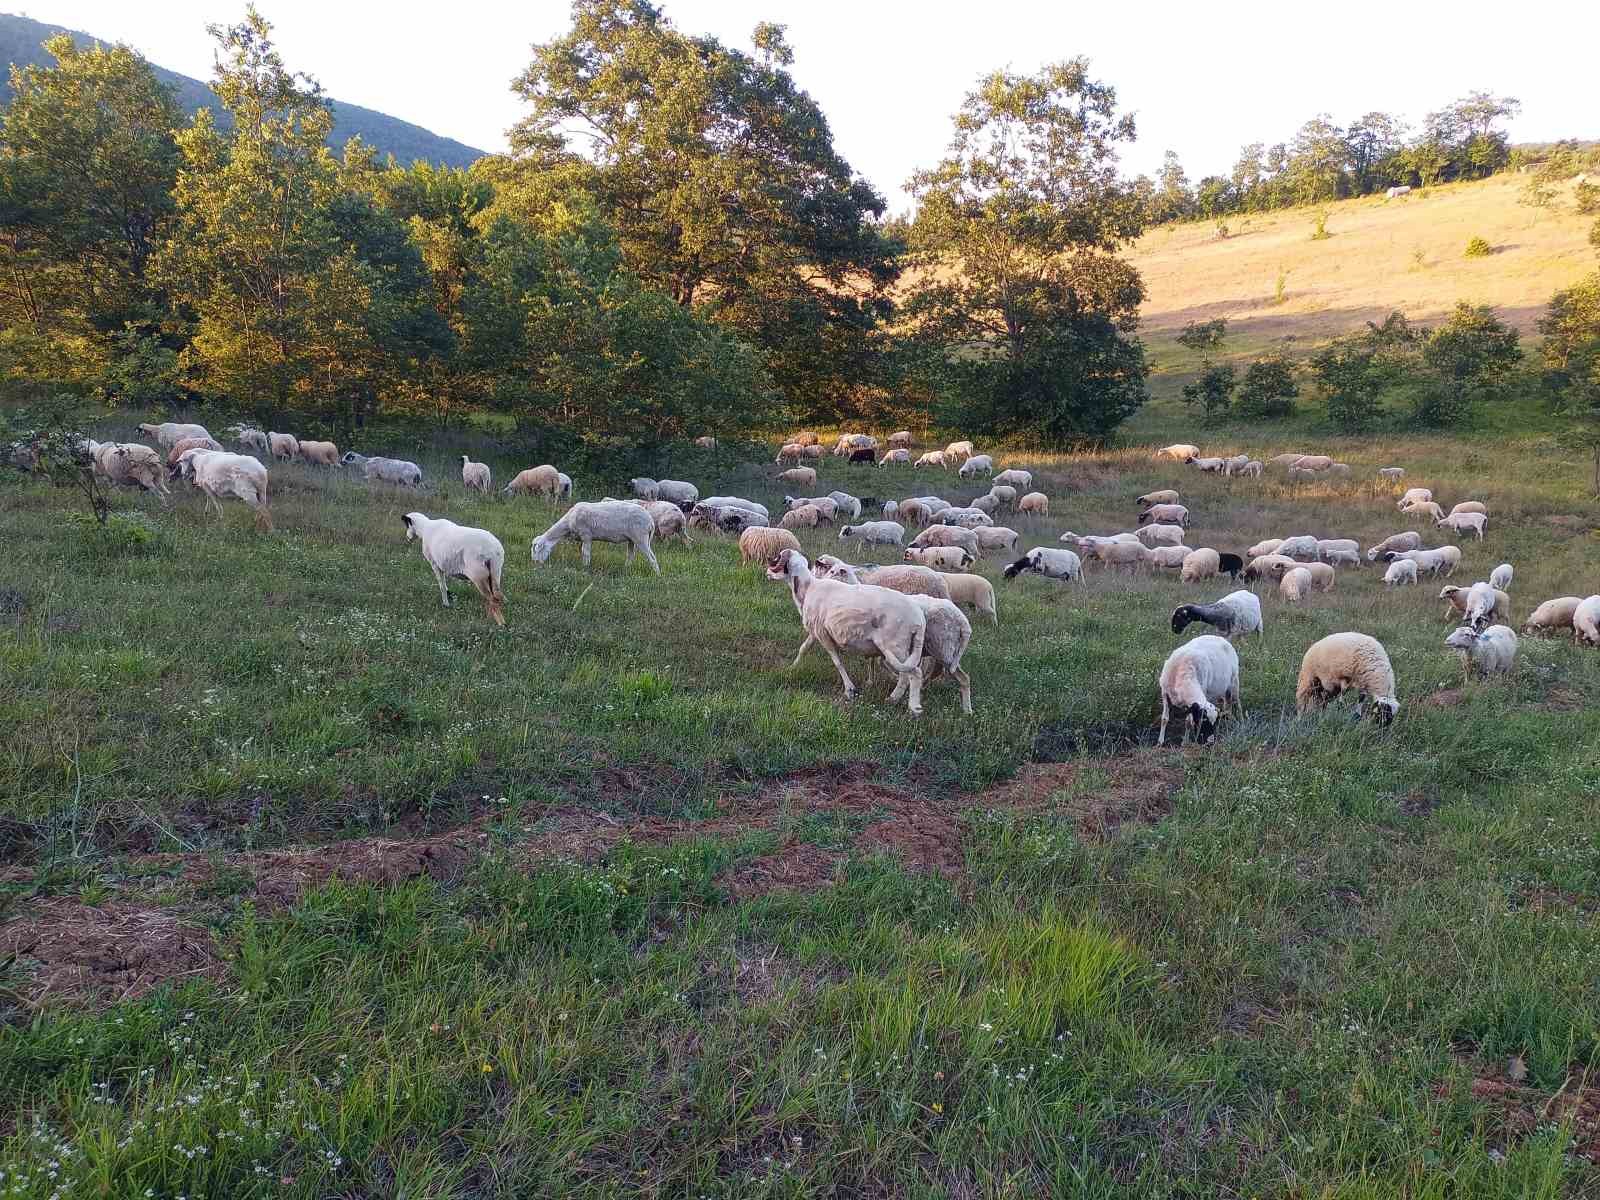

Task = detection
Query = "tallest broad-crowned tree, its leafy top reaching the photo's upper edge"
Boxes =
[512,0,898,411]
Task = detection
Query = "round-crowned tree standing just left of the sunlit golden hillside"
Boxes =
[906,59,1147,443]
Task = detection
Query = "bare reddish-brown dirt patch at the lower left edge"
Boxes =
[0,898,226,1006]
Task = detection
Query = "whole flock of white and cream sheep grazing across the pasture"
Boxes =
[25,422,1600,742]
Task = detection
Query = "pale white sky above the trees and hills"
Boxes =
[15,0,1600,210]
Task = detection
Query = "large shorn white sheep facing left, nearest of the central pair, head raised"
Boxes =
[766,550,928,717]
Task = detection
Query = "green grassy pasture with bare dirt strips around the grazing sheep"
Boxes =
[0,418,1600,1200]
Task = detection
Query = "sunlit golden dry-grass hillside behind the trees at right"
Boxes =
[1123,174,1595,440]
